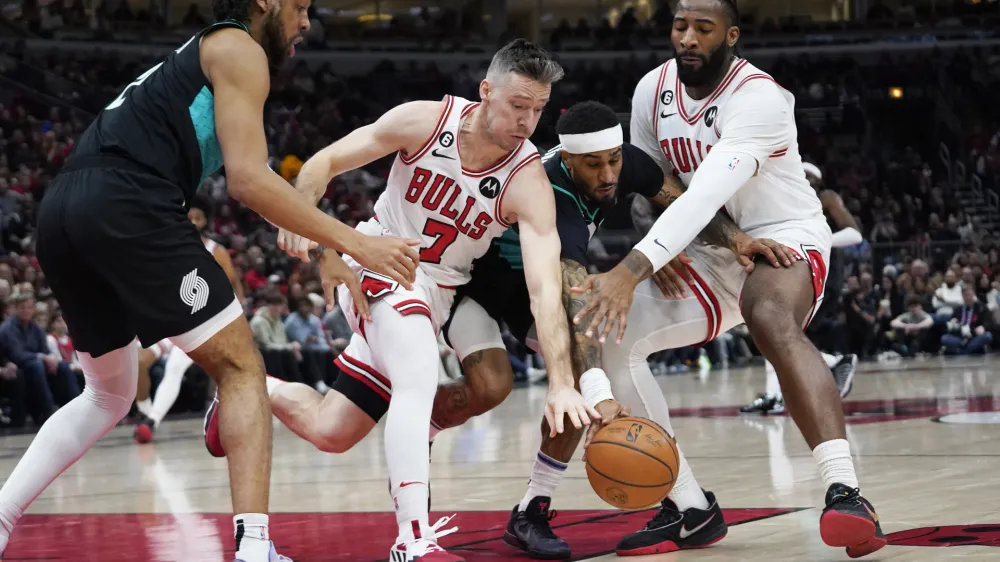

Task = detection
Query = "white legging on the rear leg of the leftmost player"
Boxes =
[0,343,139,552]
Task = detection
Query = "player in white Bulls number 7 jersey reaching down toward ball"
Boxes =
[206,39,600,562]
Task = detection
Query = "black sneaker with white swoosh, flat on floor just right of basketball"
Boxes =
[617,492,729,556]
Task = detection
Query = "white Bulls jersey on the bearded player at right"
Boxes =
[631,54,829,234]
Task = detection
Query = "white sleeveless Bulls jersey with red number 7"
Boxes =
[375,96,540,286]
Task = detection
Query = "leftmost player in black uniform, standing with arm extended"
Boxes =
[0,0,419,562]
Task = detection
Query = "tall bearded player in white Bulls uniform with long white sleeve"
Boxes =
[576,0,886,557]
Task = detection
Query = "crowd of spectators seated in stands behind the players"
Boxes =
[0,7,1000,426]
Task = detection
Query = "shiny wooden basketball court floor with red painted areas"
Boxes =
[0,358,1000,562]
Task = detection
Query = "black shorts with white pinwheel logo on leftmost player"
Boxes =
[37,167,243,357]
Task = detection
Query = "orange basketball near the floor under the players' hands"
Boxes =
[587,417,680,509]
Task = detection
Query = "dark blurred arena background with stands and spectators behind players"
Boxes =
[0,0,1000,427]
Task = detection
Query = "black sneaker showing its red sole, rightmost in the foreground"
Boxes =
[819,484,886,558]
